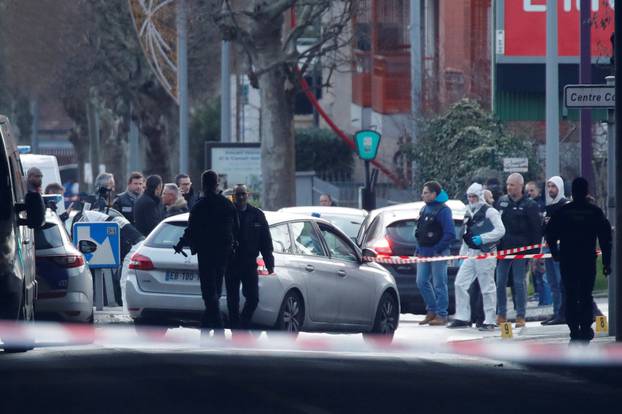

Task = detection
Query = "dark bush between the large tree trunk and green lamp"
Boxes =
[296,128,354,181]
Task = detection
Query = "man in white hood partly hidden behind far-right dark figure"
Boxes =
[542,175,568,325]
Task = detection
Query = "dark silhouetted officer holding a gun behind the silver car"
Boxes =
[175,170,237,334]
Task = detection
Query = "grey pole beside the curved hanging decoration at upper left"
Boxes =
[177,0,190,173]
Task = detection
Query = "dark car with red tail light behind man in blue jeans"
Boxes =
[358,200,466,314]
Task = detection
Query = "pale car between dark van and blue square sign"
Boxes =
[35,209,93,323]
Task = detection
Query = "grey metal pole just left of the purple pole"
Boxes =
[546,0,559,179]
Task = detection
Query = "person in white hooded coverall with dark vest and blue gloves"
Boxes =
[447,183,505,331]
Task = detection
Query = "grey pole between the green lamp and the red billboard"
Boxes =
[410,0,425,183]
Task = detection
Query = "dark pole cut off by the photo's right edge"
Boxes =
[609,2,622,342]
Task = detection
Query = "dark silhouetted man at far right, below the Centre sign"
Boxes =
[545,177,611,342]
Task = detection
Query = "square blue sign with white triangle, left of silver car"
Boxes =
[72,221,121,269]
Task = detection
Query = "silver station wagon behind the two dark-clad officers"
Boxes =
[124,212,399,337]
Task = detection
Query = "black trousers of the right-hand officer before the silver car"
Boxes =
[225,259,259,329]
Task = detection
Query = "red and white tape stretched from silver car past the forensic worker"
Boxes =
[364,244,602,264]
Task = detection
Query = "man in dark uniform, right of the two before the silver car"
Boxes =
[225,185,274,329]
